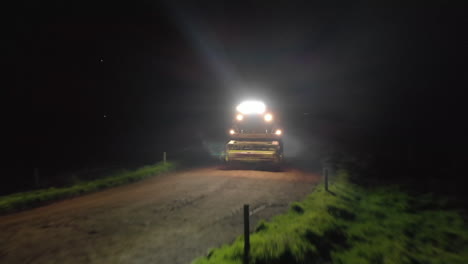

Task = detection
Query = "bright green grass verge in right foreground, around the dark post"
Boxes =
[193,172,468,264]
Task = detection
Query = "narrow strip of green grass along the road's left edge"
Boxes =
[0,162,175,214]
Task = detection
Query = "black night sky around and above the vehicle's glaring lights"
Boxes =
[15,1,467,192]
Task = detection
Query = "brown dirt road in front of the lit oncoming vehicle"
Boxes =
[0,167,319,264]
